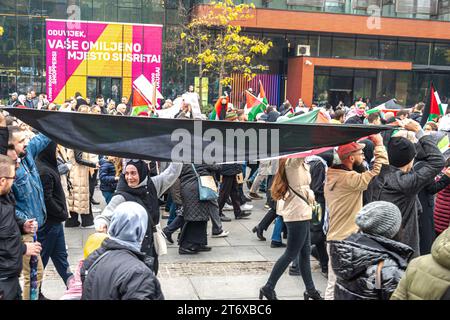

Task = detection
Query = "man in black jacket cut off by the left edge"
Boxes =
[0,155,41,300]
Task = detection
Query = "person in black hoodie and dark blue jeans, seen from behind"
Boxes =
[36,142,73,285]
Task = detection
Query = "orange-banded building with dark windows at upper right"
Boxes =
[197,0,450,105]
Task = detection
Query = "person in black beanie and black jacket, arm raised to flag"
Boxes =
[367,120,445,257]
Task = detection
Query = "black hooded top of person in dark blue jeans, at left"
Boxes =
[36,142,68,223]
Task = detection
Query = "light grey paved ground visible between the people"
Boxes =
[38,190,326,300]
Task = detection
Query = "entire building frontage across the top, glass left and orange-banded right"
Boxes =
[0,0,450,105]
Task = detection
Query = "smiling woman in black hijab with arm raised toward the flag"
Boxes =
[94,160,183,274]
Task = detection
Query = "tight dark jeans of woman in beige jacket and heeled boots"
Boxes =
[266,221,315,290]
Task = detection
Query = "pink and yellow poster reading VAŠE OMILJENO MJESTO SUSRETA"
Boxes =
[46,19,162,103]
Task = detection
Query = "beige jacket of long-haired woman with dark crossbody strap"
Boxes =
[277,158,314,222]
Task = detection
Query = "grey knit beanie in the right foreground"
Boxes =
[355,201,402,239]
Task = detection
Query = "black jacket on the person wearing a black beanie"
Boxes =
[367,136,445,257]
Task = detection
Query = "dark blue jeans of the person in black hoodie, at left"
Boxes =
[37,223,72,284]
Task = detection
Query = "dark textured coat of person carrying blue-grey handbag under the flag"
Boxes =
[180,164,220,221]
